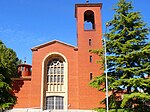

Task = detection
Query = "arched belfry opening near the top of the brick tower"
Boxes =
[84,10,95,30]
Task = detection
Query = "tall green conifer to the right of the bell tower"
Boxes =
[90,0,150,112]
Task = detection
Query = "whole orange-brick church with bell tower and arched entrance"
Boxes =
[11,3,105,112]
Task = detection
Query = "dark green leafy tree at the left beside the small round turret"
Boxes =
[0,41,19,110]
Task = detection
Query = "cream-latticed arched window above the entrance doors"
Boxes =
[47,57,64,91]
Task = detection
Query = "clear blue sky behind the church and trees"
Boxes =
[0,0,150,64]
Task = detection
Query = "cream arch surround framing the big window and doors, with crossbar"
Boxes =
[41,52,68,110]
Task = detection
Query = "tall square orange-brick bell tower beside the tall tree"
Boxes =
[75,1,105,109]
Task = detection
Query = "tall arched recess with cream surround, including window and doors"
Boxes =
[41,52,68,110]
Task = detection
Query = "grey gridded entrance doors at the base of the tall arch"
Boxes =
[46,96,64,110]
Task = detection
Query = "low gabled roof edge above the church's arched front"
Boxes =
[31,40,78,51]
